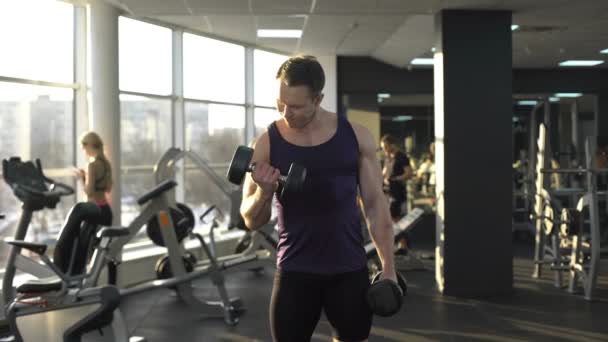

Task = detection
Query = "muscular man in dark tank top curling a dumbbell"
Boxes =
[241,56,396,342]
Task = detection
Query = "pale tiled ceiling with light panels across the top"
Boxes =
[117,0,608,68]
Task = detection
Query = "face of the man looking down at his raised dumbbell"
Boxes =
[277,80,322,128]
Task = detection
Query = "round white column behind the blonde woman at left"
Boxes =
[89,0,121,224]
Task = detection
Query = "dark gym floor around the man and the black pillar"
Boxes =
[115,242,608,342]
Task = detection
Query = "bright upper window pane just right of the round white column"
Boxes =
[118,17,173,95]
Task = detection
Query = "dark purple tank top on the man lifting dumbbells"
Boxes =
[268,115,367,274]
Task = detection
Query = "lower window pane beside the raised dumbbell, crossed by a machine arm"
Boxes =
[184,102,245,219]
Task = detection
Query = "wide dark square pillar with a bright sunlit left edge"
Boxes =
[434,10,513,297]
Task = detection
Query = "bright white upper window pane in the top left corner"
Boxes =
[0,0,74,83]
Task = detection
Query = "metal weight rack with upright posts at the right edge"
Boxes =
[533,124,608,300]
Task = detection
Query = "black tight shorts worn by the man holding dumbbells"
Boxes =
[270,268,372,342]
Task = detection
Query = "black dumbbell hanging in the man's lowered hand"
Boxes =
[367,272,407,317]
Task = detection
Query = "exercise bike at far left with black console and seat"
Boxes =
[2,157,137,342]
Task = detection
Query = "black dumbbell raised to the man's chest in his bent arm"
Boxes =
[226,146,306,197]
